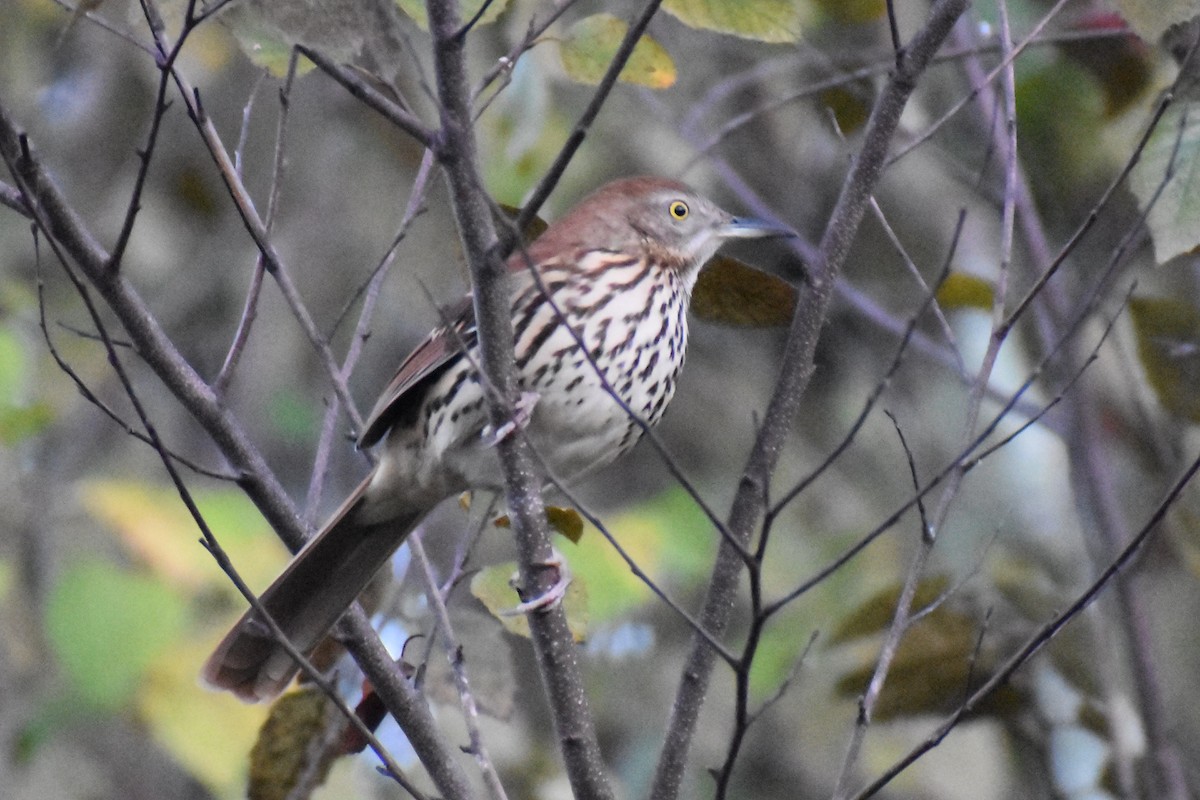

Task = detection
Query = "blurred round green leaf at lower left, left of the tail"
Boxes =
[46,561,187,710]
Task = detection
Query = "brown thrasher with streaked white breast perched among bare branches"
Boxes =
[204,178,790,700]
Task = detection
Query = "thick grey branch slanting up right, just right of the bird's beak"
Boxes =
[650,0,968,800]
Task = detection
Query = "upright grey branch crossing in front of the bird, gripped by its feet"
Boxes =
[427,0,613,798]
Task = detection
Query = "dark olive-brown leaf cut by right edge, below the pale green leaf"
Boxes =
[1129,297,1200,422]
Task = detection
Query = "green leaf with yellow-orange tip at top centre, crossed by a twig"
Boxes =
[559,14,676,89]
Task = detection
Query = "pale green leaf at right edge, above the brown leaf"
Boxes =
[1129,103,1200,264]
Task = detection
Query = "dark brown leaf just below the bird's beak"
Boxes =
[691,255,797,327]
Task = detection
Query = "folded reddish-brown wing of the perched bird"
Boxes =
[359,295,476,447]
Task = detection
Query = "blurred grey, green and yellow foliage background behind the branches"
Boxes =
[0,0,1200,800]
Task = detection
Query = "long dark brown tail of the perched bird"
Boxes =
[202,476,428,703]
